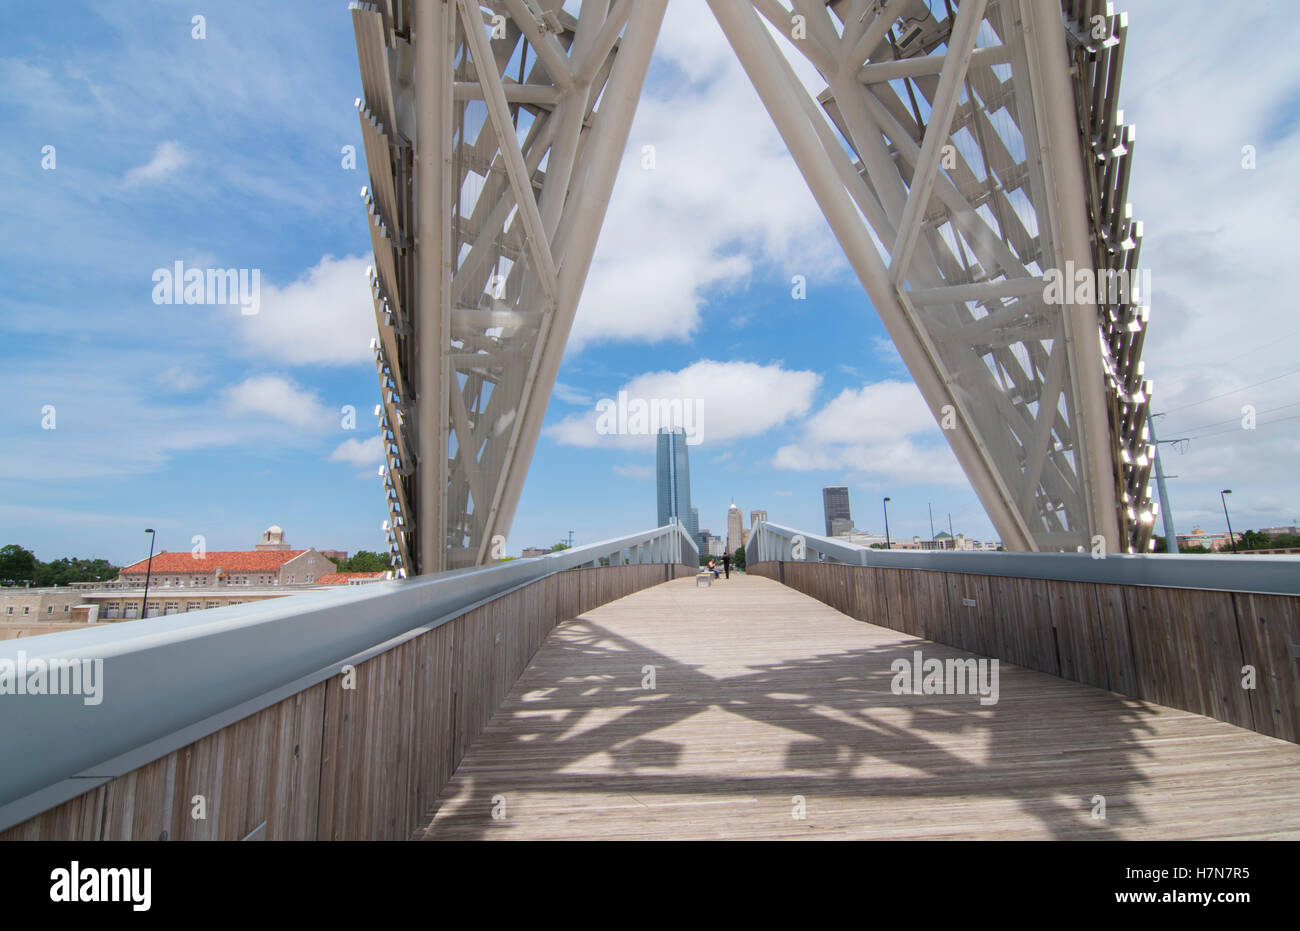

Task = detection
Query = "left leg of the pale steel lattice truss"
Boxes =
[351,0,667,573]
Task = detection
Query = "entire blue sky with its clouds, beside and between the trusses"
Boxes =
[0,0,1300,562]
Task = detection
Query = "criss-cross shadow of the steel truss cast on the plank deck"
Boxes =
[416,577,1190,840]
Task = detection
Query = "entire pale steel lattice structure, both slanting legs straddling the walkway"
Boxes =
[352,0,1154,572]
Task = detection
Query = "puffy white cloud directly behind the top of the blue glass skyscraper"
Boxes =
[545,359,822,447]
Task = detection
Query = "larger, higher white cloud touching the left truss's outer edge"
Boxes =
[228,255,374,365]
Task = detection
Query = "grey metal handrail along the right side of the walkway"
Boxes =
[745,521,1300,594]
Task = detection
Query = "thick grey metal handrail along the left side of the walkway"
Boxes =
[0,524,699,830]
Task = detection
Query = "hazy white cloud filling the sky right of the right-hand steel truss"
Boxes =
[1121,0,1300,533]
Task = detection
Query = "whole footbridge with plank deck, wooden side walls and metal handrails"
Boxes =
[0,524,1300,840]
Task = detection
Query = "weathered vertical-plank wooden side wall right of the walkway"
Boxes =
[748,557,1300,742]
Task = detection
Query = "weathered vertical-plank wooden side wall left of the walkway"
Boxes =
[0,563,696,840]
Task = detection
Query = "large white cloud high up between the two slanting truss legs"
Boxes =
[569,3,846,350]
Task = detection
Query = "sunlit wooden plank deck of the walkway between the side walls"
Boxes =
[416,576,1300,840]
